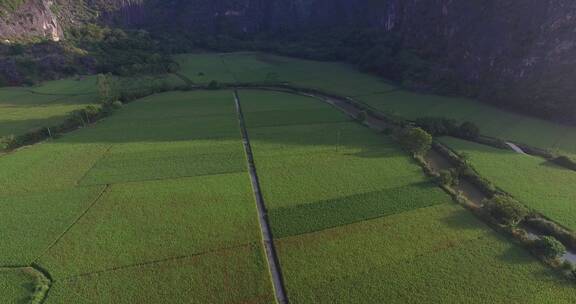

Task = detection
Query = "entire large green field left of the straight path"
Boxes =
[0,91,272,303]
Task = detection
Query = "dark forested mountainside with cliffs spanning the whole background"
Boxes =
[0,0,576,122]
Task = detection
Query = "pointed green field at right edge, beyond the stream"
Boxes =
[442,138,576,229]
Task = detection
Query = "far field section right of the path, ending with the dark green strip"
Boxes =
[240,92,445,237]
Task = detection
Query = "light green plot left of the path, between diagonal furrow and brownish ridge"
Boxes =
[40,174,259,278]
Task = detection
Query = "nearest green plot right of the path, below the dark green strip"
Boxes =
[278,204,576,303]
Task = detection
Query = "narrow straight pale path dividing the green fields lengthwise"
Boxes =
[234,91,288,304]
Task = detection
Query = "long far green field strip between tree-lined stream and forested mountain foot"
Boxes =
[177,52,576,155]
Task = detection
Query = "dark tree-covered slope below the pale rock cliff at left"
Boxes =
[0,24,178,87]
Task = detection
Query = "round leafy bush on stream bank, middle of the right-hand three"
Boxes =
[484,195,530,226]
